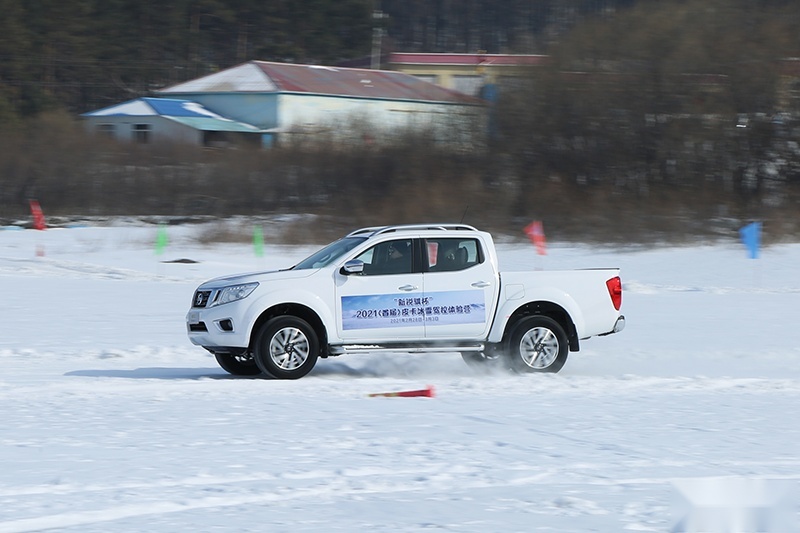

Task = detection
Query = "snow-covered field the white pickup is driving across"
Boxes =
[0,222,800,533]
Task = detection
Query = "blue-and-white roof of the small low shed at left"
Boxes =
[81,97,261,133]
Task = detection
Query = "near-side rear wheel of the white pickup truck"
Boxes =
[506,316,569,372]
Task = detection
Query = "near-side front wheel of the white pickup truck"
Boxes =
[253,316,319,379]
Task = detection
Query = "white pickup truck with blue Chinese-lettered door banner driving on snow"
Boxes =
[186,224,625,379]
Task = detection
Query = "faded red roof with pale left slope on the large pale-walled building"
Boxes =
[157,61,484,105]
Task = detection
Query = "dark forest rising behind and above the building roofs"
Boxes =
[0,0,644,119]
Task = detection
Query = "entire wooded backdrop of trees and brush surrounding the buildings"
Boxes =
[0,0,800,241]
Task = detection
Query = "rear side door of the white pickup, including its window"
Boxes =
[421,236,499,340]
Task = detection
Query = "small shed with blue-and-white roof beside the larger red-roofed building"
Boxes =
[81,97,263,147]
